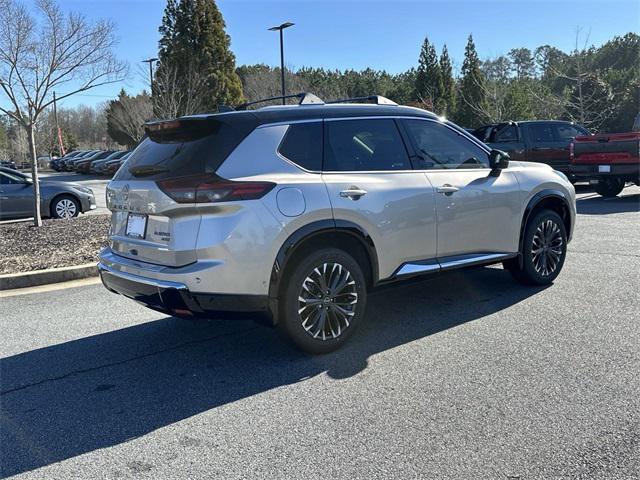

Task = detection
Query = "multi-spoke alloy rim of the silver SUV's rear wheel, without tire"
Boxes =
[298,262,358,341]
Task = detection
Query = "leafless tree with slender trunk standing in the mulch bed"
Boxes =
[0,0,126,226]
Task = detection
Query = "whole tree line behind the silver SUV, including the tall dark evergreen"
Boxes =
[101,0,640,150]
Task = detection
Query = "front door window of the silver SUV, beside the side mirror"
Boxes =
[404,120,489,169]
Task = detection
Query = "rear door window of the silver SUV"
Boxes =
[324,118,411,171]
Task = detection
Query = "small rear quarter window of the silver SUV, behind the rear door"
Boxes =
[278,122,322,171]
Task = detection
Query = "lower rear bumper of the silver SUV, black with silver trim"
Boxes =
[98,256,273,323]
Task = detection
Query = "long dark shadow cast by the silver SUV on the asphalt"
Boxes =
[0,268,542,477]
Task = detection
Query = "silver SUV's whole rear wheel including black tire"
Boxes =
[279,248,367,354]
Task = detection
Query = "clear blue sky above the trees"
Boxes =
[42,0,640,107]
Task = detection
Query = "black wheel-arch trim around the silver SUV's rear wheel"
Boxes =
[269,220,378,324]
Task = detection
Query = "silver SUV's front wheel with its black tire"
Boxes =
[504,210,567,285]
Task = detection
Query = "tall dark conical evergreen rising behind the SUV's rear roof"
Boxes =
[154,0,243,114]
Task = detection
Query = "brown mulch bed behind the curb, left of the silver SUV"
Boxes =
[0,215,111,274]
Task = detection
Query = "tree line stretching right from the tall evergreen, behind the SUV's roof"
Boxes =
[237,33,640,132]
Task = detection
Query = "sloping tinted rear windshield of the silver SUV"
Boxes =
[114,119,255,180]
